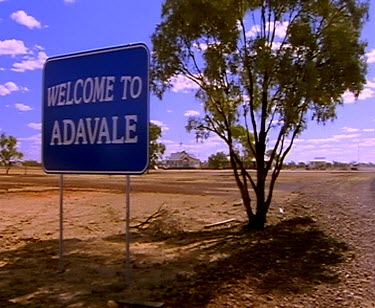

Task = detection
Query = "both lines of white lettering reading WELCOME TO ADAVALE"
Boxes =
[47,76,142,146]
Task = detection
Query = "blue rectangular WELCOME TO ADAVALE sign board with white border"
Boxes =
[42,44,150,174]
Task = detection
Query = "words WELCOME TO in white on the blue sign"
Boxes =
[47,76,142,107]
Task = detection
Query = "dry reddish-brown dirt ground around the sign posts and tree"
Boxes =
[0,170,375,308]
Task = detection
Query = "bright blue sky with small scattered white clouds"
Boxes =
[0,0,375,162]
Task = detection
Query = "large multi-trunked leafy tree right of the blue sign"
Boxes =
[152,0,368,229]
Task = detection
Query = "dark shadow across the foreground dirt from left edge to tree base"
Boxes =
[0,217,348,307]
